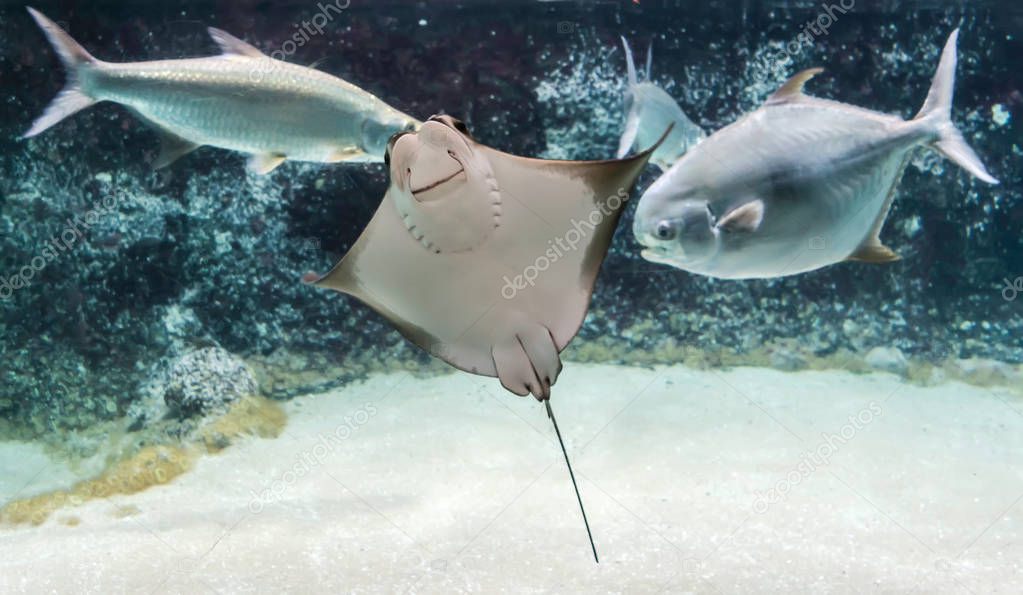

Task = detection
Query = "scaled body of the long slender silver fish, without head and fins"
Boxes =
[93,57,374,162]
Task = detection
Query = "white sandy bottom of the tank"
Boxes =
[0,364,1023,593]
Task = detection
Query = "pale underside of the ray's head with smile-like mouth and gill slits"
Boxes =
[385,116,501,253]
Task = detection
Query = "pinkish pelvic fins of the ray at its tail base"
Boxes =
[491,324,562,401]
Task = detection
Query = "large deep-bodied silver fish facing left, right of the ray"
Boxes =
[633,30,997,279]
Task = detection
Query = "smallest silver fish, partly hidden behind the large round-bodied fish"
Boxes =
[617,37,707,172]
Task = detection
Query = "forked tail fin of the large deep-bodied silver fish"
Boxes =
[915,29,998,184]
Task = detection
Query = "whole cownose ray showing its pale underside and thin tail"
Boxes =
[304,116,663,559]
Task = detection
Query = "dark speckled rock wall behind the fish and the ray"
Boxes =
[0,0,1023,432]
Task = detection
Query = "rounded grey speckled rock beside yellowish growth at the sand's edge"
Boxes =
[164,347,259,417]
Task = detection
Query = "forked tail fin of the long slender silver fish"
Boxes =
[21,6,98,138]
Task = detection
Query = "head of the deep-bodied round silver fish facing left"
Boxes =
[632,177,720,268]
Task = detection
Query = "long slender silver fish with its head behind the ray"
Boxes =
[25,8,420,173]
